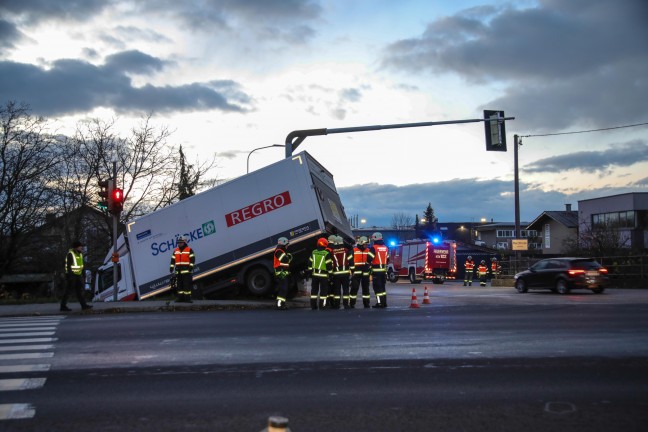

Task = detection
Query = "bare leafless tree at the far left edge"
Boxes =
[0,102,60,273]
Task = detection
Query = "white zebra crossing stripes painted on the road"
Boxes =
[0,316,65,422]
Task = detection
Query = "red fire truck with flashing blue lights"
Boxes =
[387,240,457,284]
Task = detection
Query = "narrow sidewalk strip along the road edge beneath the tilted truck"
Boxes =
[0,297,310,317]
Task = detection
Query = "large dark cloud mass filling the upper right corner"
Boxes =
[383,0,648,130]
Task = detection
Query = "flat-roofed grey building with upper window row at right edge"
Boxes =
[578,192,648,251]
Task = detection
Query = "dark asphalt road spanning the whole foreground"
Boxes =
[0,284,648,432]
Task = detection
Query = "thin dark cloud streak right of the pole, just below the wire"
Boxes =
[522,140,648,173]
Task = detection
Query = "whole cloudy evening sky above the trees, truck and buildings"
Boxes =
[0,0,648,226]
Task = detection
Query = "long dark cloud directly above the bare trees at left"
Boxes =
[0,51,251,116]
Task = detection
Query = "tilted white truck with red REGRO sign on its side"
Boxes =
[94,152,353,301]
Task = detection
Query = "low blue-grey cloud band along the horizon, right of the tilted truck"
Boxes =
[338,179,648,226]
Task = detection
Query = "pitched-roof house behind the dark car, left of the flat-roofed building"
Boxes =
[526,204,578,255]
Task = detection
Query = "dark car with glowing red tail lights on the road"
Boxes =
[515,258,610,294]
